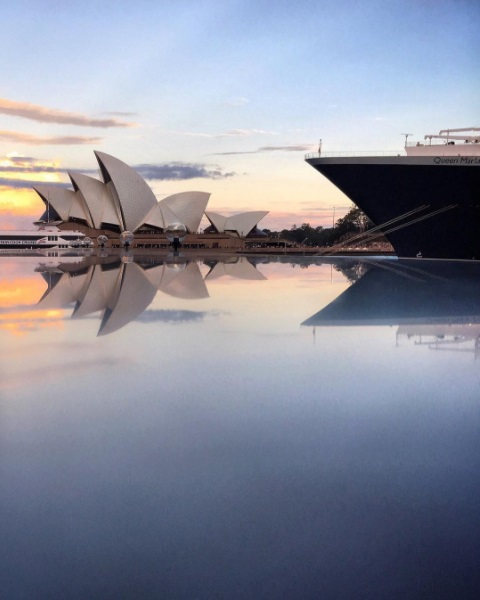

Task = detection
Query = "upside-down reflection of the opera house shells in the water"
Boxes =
[36,257,265,335]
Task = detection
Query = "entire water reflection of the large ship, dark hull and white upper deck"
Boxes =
[302,260,480,356]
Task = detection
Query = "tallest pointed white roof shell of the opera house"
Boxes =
[95,151,157,232]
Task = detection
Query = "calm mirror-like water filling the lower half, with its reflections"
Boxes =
[0,251,480,600]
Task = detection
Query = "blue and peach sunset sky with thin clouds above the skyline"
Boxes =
[0,0,480,230]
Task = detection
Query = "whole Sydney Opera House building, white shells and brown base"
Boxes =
[34,152,268,248]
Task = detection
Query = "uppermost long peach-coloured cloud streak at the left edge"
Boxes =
[0,98,135,128]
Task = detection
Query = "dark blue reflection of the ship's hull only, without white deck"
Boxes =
[302,260,480,326]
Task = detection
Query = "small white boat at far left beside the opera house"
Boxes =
[0,225,85,250]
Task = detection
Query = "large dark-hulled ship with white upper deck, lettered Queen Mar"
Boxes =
[305,127,480,260]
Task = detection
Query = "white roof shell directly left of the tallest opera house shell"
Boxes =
[68,173,120,229]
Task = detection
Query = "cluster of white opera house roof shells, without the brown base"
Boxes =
[33,151,268,236]
